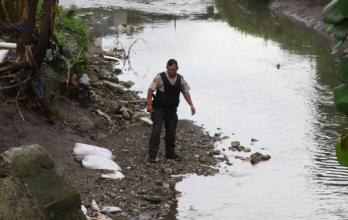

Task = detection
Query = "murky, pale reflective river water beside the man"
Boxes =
[68,0,348,220]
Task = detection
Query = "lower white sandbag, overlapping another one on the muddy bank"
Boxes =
[82,155,121,171]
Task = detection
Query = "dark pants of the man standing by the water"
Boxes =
[149,108,178,159]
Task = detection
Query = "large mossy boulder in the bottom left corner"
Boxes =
[0,145,85,220]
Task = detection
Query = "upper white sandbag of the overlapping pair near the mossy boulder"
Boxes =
[73,143,112,159]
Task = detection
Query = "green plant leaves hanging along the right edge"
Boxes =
[323,0,348,167]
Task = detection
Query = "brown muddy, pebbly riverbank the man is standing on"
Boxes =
[0,40,223,219]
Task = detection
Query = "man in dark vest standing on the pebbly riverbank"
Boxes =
[147,59,196,163]
